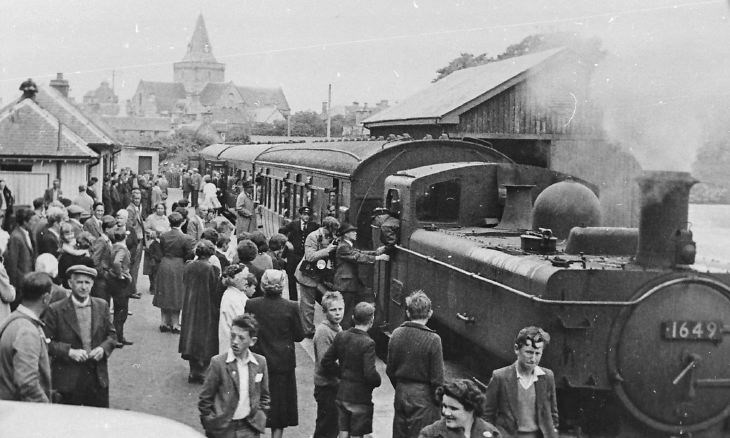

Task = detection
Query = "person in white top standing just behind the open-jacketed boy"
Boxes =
[218,265,256,354]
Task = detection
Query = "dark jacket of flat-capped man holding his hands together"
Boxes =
[43,297,117,392]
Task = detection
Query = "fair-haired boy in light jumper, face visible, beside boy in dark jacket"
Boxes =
[313,292,345,438]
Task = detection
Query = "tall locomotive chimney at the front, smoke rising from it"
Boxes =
[636,171,697,268]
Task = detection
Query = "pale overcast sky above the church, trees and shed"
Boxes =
[0,0,730,169]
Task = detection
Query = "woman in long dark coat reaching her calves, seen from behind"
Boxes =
[178,240,219,383]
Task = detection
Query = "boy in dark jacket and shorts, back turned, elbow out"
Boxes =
[322,302,380,438]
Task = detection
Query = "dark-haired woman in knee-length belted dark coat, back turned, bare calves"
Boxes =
[152,212,195,333]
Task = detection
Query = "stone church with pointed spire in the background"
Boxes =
[127,14,290,133]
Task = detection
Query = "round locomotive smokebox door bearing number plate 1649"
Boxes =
[608,275,730,434]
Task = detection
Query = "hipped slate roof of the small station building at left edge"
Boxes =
[0,99,98,159]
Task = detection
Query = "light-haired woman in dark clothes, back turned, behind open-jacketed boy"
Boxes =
[245,268,304,438]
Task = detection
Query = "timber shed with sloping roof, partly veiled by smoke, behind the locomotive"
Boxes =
[363,48,641,226]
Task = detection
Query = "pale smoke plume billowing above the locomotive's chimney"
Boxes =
[590,3,730,171]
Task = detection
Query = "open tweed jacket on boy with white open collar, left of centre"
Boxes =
[198,352,271,438]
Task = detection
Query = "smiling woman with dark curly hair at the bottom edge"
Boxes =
[418,379,501,438]
